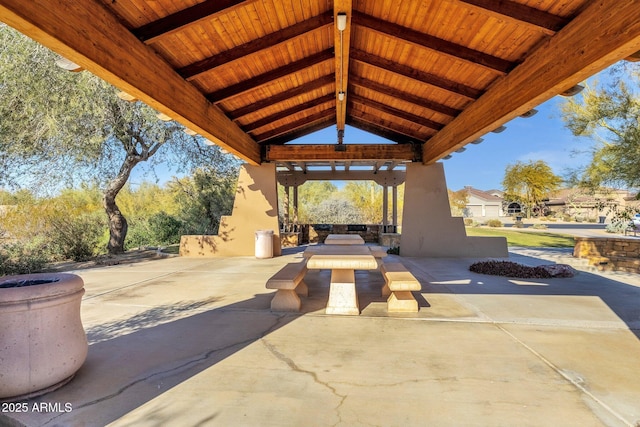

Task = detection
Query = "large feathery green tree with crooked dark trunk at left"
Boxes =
[0,24,236,254]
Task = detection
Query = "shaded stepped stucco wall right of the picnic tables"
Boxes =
[400,163,508,257]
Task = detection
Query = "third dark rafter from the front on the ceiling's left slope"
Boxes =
[207,49,333,103]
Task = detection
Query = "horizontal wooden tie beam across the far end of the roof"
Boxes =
[266,144,415,162]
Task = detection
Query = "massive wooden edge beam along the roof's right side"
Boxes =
[423,0,640,164]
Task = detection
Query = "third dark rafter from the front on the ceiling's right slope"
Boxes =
[351,49,482,100]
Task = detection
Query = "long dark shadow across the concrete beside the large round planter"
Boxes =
[14,294,300,427]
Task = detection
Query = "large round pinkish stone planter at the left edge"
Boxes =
[0,273,88,400]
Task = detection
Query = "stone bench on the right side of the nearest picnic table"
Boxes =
[380,262,422,313]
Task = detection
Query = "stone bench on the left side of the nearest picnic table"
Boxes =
[267,260,309,311]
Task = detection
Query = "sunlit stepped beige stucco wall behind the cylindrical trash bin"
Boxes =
[180,163,281,257]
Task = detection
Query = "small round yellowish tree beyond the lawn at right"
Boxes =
[502,160,562,218]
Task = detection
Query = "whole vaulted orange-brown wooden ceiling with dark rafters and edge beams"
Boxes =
[0,0,640,164]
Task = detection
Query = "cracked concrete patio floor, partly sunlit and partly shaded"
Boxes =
[0,249,640,427]
